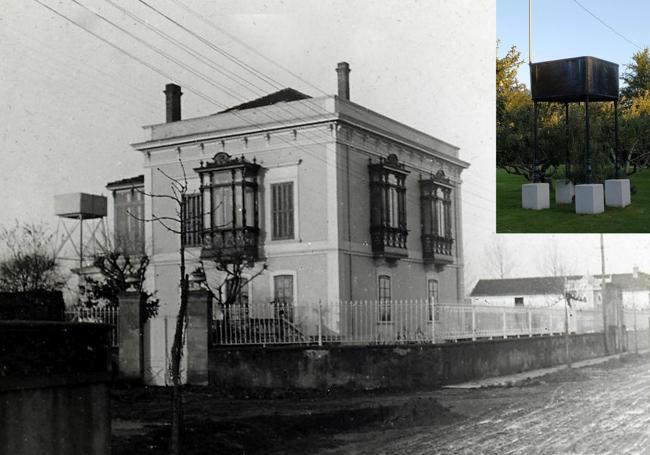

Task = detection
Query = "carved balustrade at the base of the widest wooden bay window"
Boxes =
[201,227,260,261]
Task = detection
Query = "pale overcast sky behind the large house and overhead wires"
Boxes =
[0,0,650,294]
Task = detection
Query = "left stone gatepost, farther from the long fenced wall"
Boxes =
[118,291,144,381]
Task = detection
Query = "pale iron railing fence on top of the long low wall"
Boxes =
[210,300,650,345]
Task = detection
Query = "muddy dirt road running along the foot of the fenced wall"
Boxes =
[113,357,650,455]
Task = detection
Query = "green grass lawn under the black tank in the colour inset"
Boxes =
[496,169,650,233]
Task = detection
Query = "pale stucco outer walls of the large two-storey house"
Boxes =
[133,91,468,384]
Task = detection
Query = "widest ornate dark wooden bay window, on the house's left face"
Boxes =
[195,153,260,262]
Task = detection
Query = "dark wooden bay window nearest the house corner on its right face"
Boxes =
[368,154,409,259]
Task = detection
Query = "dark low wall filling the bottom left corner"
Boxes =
[0,321,111,455]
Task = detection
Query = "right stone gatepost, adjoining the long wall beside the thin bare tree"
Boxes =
[185,289,210,385]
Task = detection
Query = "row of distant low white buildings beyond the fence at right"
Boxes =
[470,268,650,309]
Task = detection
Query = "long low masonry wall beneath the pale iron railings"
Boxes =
[209,331,648,390]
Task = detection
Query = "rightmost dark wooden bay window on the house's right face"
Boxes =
[420,171,454,265]
